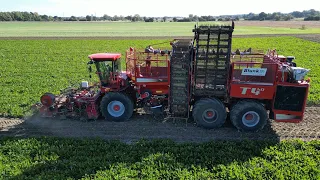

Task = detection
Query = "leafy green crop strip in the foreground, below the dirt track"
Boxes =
[0,137,320,179]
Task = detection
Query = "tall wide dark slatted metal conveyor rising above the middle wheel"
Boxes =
[193,26,234,97]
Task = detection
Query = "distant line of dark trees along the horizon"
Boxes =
[0,9,320,22]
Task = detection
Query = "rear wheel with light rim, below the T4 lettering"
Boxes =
[230,100,268,131]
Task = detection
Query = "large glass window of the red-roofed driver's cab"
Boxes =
[95,61,113,85]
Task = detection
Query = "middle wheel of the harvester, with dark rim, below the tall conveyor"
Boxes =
[192,98,227,129]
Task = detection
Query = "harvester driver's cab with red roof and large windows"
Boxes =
[88,53,121,87]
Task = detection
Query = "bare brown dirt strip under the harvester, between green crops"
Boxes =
[0,107,320,142]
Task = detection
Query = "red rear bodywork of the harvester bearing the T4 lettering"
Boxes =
[228,50,309,123]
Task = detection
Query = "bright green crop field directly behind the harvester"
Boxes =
[0,37,320,117]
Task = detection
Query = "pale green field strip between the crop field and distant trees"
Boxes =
[0,22,320,37]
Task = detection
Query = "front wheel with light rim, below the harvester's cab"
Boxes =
[100,92,133,122]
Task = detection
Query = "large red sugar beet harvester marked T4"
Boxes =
[39,24,309,131]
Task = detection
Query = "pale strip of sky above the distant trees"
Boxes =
[0,0,320,17]
